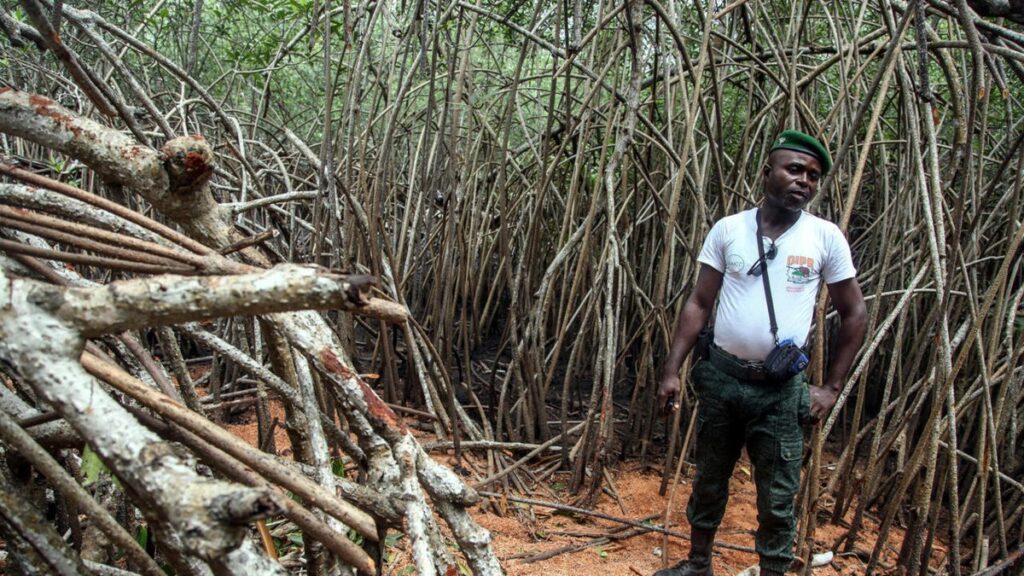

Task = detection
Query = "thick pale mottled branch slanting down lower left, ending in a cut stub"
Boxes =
[0,276,278,573]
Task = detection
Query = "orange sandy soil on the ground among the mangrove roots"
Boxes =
[227,403,933,576]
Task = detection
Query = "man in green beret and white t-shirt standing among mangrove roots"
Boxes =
[655,130,866,576]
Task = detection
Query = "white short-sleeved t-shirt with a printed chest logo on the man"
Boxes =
[697,208,857,361]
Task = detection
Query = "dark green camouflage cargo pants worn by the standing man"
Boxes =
[686,361,810,572]
